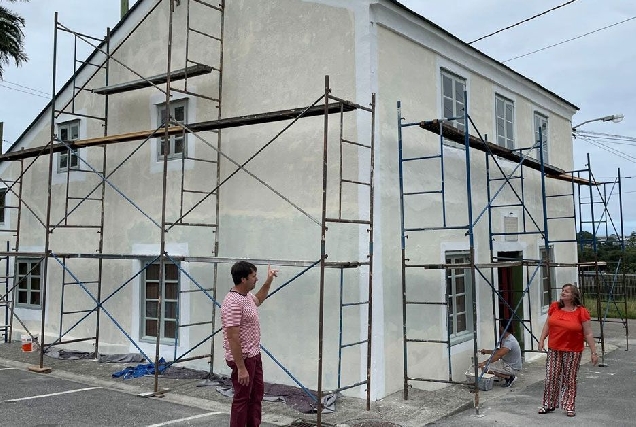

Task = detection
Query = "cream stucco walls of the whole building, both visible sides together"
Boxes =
[0,0,576,399]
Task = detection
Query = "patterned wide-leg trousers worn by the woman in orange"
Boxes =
[543,349,583,411]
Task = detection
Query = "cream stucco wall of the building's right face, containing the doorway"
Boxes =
[374,5,576,393]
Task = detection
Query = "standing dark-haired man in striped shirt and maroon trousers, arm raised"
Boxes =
[221,261,278,427]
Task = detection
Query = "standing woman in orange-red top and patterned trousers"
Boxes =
[539,283,598,417]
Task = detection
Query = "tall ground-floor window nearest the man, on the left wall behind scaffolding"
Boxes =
[141,262,179,340]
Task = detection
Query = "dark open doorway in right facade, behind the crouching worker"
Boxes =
[497,251,525,351]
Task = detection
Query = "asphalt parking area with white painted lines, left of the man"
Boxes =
[0,366,273,427]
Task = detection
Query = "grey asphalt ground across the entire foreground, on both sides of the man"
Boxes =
[0,321,636,427]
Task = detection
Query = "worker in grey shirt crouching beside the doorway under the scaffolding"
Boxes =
[479,320,521,387]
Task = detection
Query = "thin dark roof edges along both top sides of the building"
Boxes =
[7,0,579,156]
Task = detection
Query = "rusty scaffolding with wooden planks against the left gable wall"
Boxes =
[0,0,375,425]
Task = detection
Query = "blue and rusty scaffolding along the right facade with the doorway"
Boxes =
[397,92,622,412]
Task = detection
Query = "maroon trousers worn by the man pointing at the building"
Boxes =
[226,354,265,427]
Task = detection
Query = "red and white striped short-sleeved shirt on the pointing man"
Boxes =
[221,291,261,361]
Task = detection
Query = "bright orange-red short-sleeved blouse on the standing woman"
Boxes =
[548,301,591,352]
